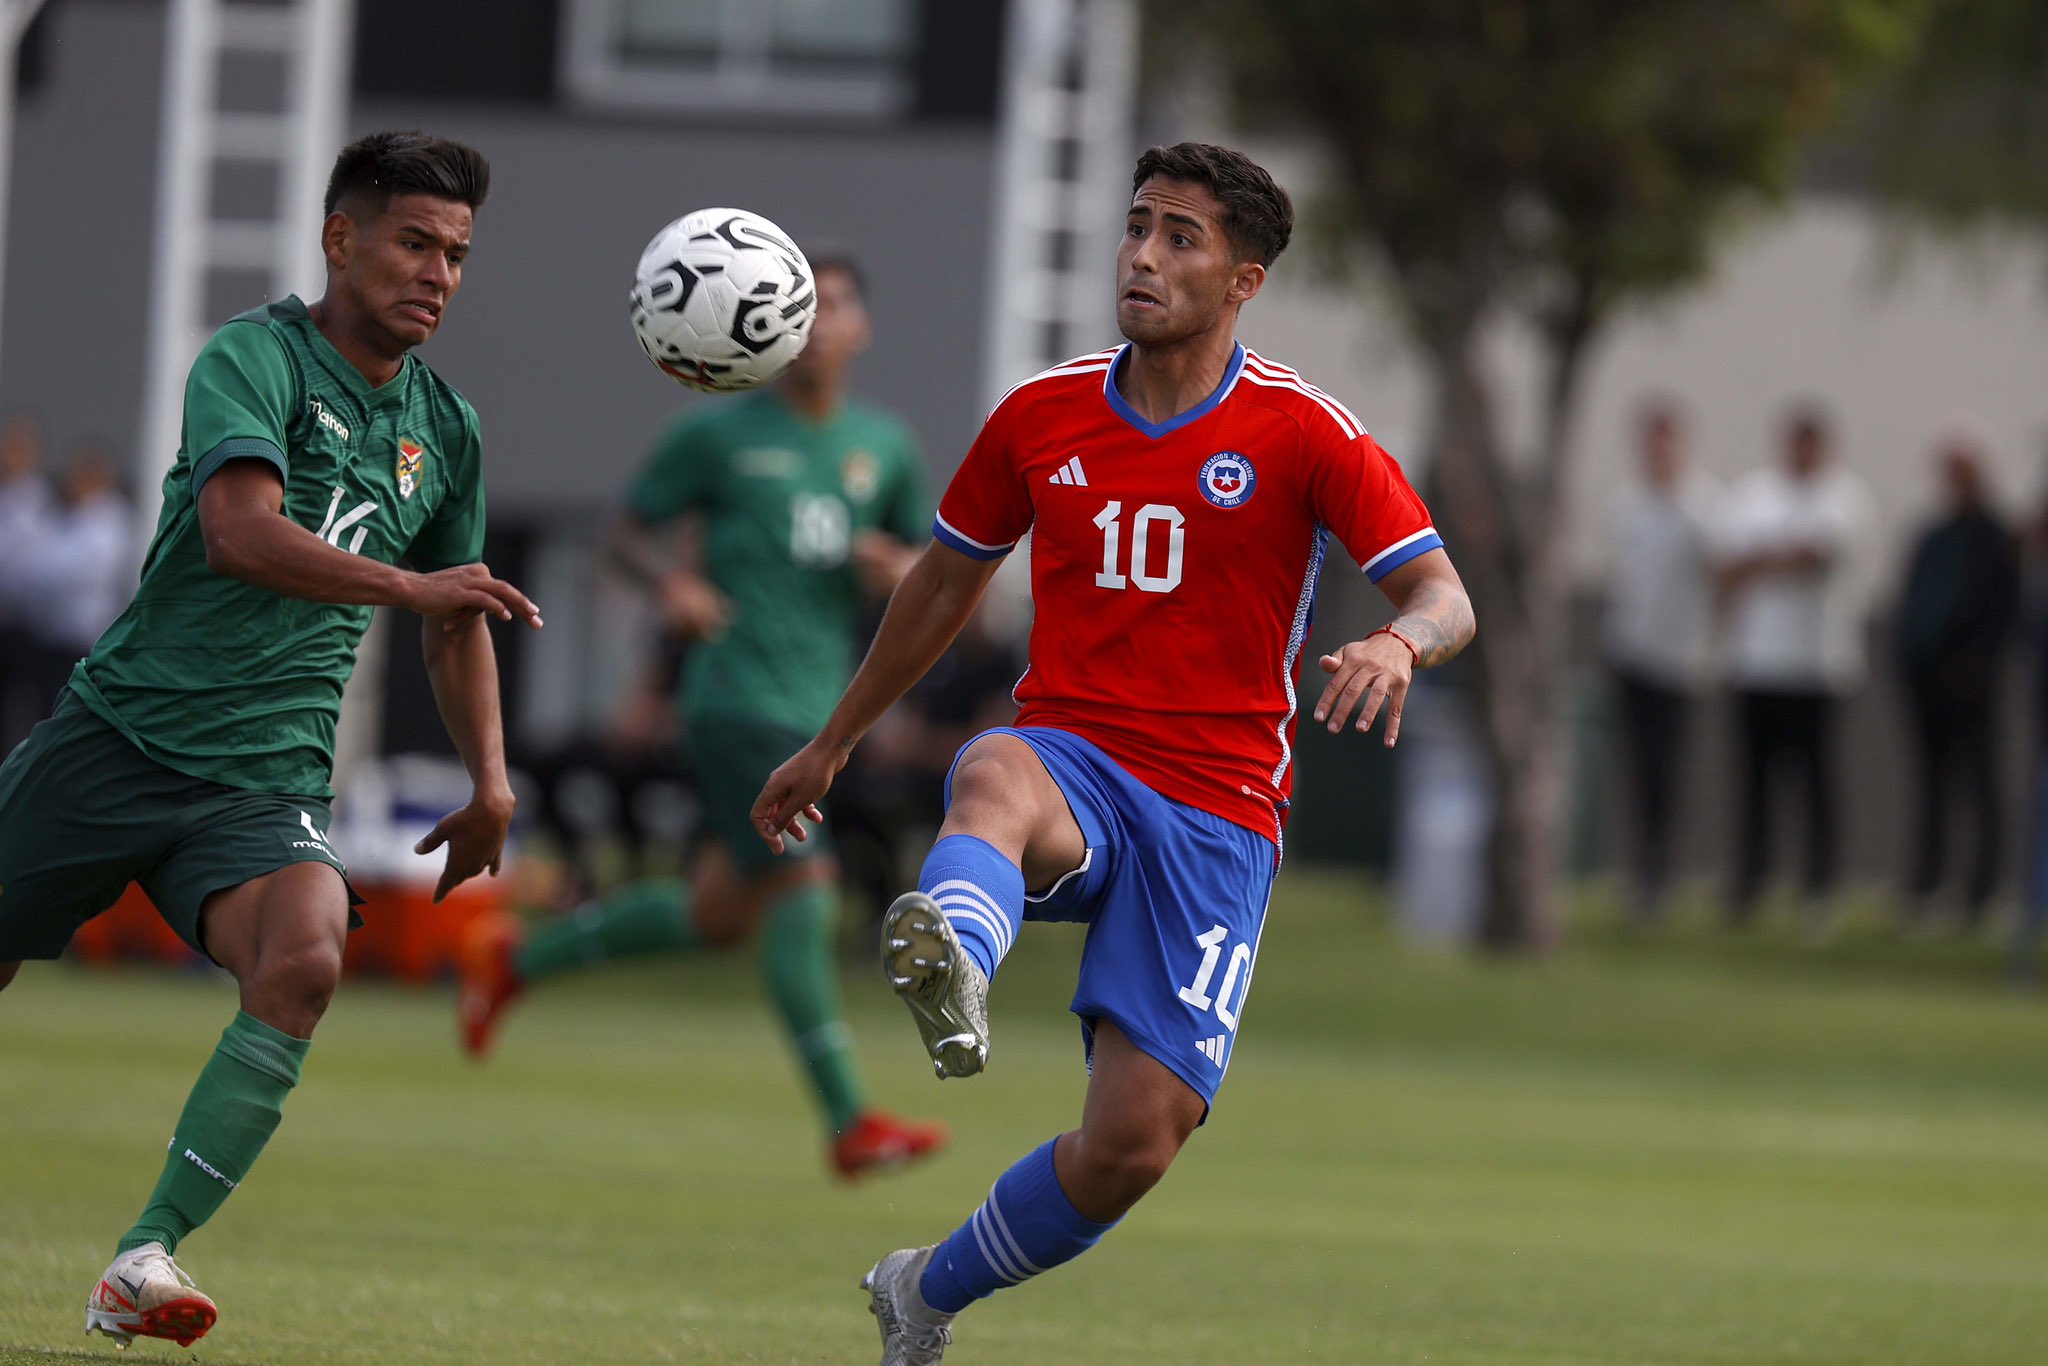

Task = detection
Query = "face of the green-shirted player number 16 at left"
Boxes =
[326,195,475,350]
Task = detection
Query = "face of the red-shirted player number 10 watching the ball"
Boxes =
[1116,176,1266,346]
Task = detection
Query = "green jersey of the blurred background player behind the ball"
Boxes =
[627,391,932,733]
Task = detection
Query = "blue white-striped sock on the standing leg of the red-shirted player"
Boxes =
[918,1139,1116,1315]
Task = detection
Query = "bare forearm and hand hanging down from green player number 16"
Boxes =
[414,612,516,901]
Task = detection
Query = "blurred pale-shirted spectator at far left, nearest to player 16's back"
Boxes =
[20,444,137,711]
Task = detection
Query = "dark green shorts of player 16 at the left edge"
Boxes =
[0,688,362,963]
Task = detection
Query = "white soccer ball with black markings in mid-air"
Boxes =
[633,209,817,393]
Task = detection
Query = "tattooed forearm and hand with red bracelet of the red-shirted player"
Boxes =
[1315,549,1475,750]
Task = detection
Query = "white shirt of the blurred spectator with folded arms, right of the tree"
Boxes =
[1726,465,1872,692]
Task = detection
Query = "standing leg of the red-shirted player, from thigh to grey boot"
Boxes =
[860,1020,1208,1366]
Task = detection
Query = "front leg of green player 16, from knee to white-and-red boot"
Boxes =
[86,862,348,1346]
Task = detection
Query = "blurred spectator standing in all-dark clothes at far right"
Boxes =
[1898,434,2019,926]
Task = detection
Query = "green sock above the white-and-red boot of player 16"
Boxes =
[115,1012,311,1253]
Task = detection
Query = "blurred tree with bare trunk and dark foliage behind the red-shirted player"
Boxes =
[1149,0,1933,944]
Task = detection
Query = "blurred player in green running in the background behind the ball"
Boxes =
[461,254,944,1176]
